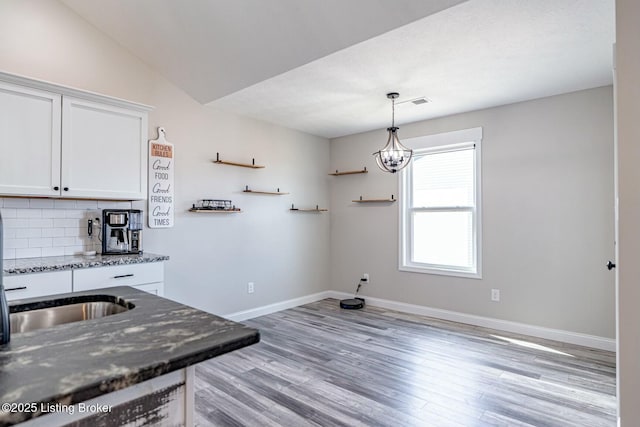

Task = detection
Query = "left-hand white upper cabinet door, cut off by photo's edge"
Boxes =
[0,82,61,196]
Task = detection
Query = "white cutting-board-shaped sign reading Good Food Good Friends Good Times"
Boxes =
[148,127,175,228]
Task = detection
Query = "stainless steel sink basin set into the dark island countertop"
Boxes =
[10,295,134,334]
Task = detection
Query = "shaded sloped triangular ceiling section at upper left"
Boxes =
[63,0,464,104]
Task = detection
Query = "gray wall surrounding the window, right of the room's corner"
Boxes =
[331,87,615,338]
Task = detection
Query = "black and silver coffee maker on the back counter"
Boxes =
[102,209,142,254]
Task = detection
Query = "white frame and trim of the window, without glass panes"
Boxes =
[398,127,482,279]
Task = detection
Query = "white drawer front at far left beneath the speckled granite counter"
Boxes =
[3,270,72,301]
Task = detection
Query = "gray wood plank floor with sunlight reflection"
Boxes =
[195,299,616,427]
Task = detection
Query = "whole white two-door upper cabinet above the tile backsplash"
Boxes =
[0,72,151,200]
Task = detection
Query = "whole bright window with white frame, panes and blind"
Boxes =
[400,128,482,278]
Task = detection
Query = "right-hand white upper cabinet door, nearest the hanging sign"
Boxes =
[61,96,147,200]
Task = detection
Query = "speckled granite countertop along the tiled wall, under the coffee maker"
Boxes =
[2,252,169,276]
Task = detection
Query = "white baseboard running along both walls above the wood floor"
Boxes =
[224,291,616,352]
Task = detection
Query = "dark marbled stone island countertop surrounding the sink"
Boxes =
[0,286,260,426]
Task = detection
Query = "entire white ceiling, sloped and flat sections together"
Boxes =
[63,0,615,138]
